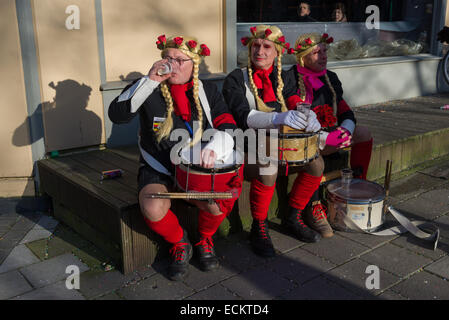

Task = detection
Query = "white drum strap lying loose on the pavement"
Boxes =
[344,206,440,250]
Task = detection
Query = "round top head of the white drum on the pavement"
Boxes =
[327,179,385,204]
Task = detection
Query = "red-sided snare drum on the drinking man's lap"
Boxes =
[175,145,243,197]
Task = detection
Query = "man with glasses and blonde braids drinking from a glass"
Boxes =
[108,35,241,280]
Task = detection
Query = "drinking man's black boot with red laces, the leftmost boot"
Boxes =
[168,230,193,281]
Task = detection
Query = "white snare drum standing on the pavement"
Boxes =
[326,179,385,232]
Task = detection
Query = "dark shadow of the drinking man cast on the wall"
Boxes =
[12,79,102,152]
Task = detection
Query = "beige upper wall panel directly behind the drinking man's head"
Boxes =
[102,0,225,81]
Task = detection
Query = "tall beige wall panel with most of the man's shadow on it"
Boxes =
[32,0,104,152]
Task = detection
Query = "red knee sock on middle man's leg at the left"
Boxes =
[249,179,276,220]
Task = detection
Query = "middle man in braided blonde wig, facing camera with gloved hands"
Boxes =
[222,25,324,257]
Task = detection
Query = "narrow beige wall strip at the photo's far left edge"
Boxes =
[0,0,33,179]
